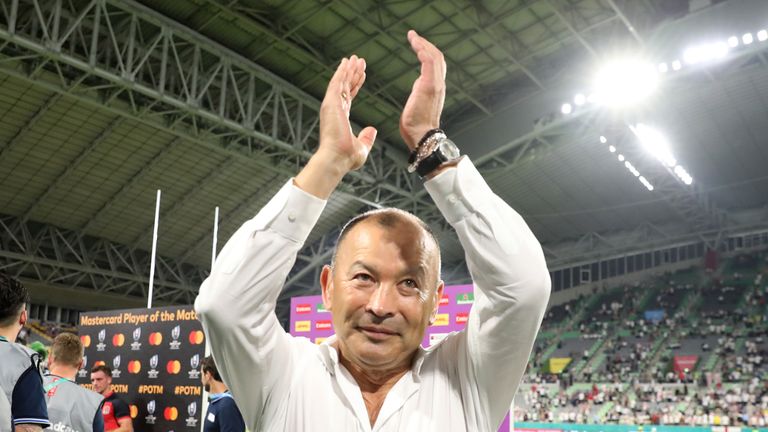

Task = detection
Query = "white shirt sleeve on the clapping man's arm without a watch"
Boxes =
[195,180,325,430]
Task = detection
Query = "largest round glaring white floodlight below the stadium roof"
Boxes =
[594,60,658,106]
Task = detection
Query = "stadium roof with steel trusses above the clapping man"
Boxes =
[0,0,768,322]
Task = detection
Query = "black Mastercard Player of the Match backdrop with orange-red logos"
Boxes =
[77,306,205,432]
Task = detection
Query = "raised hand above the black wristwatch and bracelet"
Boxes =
[400,30,446,150]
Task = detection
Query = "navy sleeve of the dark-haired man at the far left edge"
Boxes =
[11,366,51,428]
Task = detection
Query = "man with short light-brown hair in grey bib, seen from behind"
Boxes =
[43,333,104,432]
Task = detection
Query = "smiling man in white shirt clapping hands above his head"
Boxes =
[195,31,550,432]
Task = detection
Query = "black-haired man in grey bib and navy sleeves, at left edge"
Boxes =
[0,273,51,432]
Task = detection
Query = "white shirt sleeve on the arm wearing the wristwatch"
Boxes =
[425,157,550,430]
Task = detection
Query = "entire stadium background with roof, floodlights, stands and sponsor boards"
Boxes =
[0,0,768,432]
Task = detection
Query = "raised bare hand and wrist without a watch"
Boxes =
[294,55,376,198]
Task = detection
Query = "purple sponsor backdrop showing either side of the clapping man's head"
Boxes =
[290,285,511,432]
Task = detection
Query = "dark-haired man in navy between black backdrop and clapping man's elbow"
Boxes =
[200,356,245,432]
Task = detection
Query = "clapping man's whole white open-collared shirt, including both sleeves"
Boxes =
[195,158,550,432]
